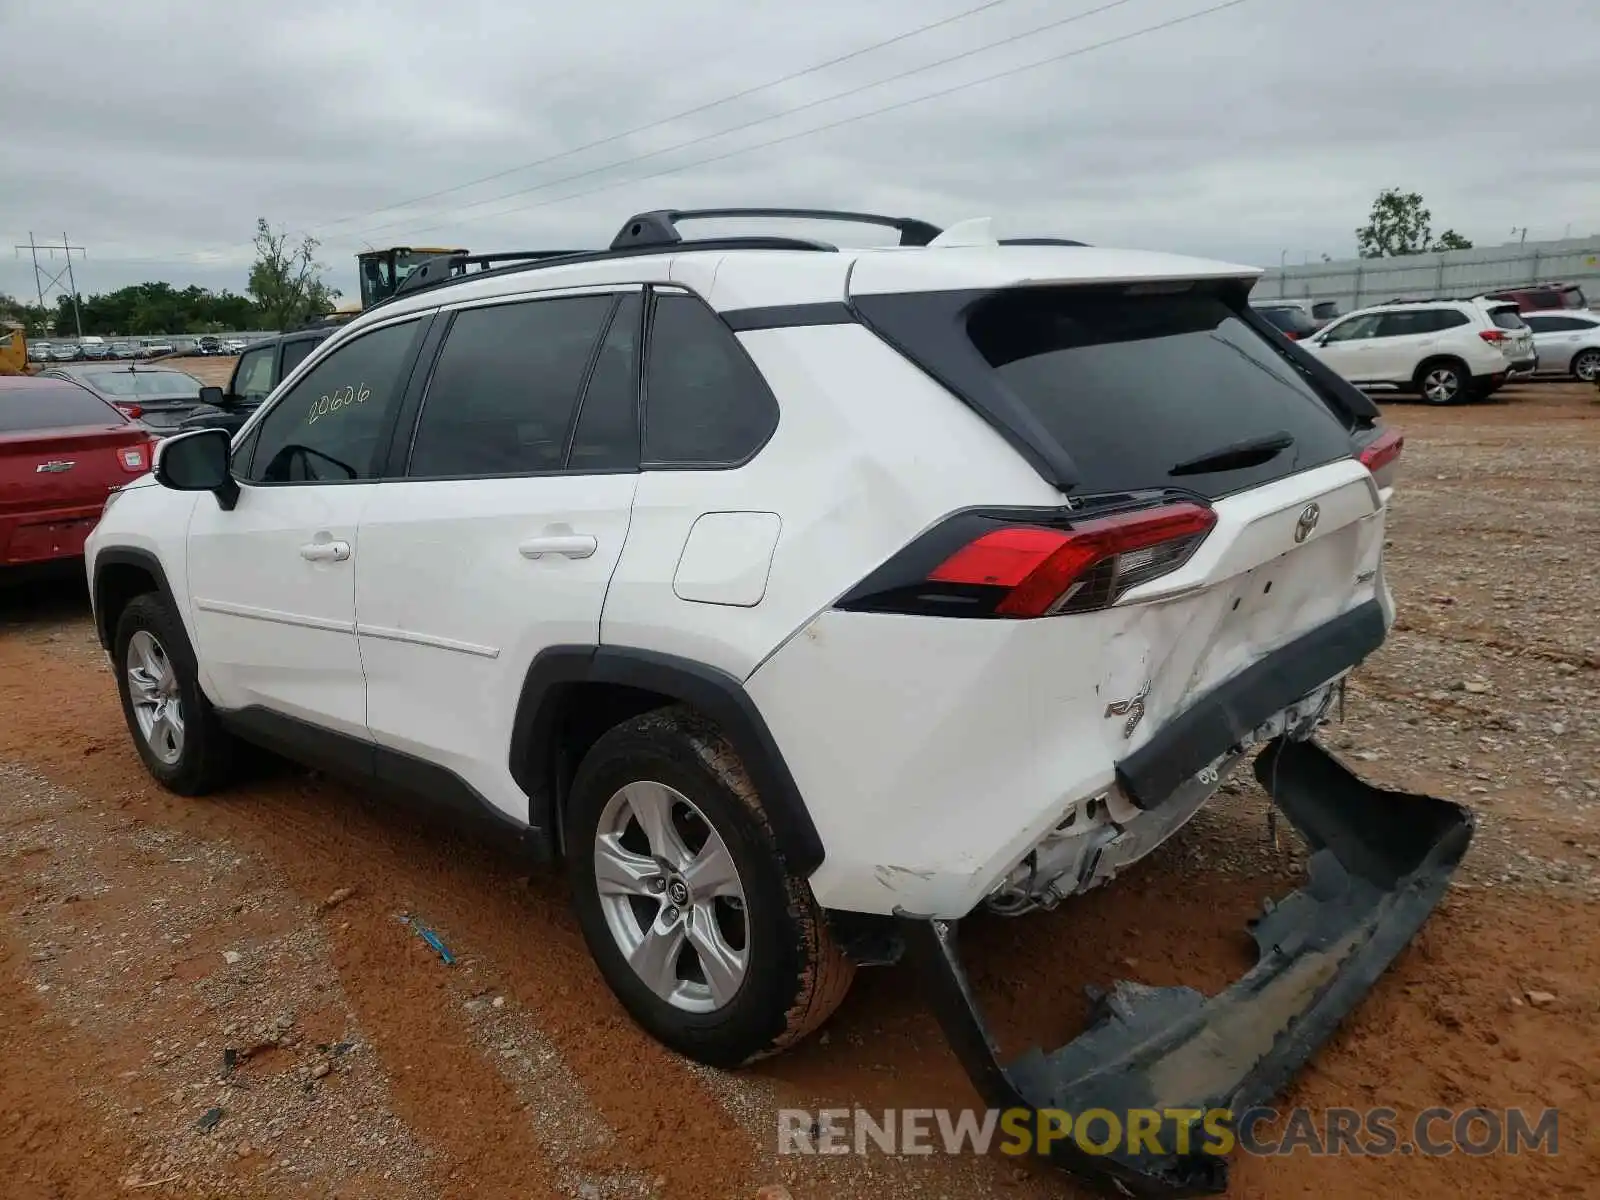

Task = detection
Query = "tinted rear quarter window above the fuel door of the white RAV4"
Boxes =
[645,293,778,466]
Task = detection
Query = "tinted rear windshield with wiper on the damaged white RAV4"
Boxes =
[968,288,1350,496]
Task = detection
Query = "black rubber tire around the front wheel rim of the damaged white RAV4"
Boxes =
[112,594,235,795]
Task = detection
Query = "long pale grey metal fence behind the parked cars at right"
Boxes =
[1251,234,1600,312]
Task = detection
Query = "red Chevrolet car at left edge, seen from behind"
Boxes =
[0,376,155,568]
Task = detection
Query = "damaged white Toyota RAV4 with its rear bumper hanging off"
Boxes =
[88,210,1472,1195]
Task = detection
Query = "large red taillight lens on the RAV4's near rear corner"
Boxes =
[928,502,1216,616]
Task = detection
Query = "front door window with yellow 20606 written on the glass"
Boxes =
[240,322,422,483]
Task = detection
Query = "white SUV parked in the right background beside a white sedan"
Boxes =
[1299,299,1536,405]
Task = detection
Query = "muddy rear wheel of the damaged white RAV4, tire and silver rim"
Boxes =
[565,707,854,1067]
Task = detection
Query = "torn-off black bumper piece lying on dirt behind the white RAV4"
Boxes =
[901,739,1474,1197]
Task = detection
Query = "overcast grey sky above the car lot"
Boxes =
[0,0,1600,296]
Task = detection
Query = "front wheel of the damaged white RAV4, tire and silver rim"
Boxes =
[112,594,234,795]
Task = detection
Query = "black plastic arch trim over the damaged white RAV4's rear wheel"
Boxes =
[510,645,822,875]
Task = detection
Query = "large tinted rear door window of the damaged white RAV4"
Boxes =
[406,296,614,478]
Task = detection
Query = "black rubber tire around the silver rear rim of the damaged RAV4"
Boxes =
[565,707,854,1067]
